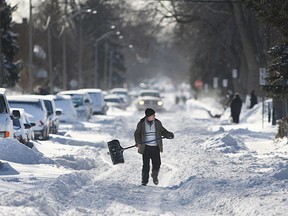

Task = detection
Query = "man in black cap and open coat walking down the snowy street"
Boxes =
[134,108,174,186]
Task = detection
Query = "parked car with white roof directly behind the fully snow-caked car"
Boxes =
[57,90,92,121]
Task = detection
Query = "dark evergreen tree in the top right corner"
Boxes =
[244,0,288,98]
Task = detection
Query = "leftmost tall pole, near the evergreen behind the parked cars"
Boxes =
[28,0,34,92]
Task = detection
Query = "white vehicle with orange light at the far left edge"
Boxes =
[0,88,14,138]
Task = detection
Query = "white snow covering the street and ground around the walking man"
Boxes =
[0,88,288,216]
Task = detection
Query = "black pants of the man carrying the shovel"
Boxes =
[142,145,161,184]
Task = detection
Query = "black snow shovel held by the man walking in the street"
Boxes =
[108,137,166,165]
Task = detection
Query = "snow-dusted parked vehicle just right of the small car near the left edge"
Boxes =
[7,95,49,140]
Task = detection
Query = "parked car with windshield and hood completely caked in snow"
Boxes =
[54,95,77,123]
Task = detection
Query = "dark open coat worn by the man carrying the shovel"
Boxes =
[134,117,171,154]
